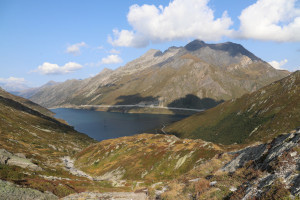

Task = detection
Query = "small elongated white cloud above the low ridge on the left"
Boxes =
[33,62,82,75]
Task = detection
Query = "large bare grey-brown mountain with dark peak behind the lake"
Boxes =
[23,40,289,112]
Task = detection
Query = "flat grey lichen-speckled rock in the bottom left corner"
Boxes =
[0,180,58,200]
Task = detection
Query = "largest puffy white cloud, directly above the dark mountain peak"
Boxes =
[108,0,233,47]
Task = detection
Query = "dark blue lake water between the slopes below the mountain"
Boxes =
[51,108,186,141]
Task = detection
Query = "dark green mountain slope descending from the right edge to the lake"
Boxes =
[165,71,300,144]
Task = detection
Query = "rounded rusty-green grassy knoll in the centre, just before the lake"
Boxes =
[76,134,222,181]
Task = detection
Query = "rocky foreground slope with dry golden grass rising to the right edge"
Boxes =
[159,129,300,200]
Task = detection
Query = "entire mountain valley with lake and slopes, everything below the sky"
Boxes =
[0,40,300,200]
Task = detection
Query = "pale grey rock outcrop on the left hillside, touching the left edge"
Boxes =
[0,149,42,171]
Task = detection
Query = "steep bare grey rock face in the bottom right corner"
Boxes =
[222,130,300,199]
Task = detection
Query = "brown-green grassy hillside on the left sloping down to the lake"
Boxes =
[0,89,95,199]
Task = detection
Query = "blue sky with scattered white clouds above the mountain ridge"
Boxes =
[0,0,300,90]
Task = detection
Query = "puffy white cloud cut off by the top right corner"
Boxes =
[236,0,300,42]
